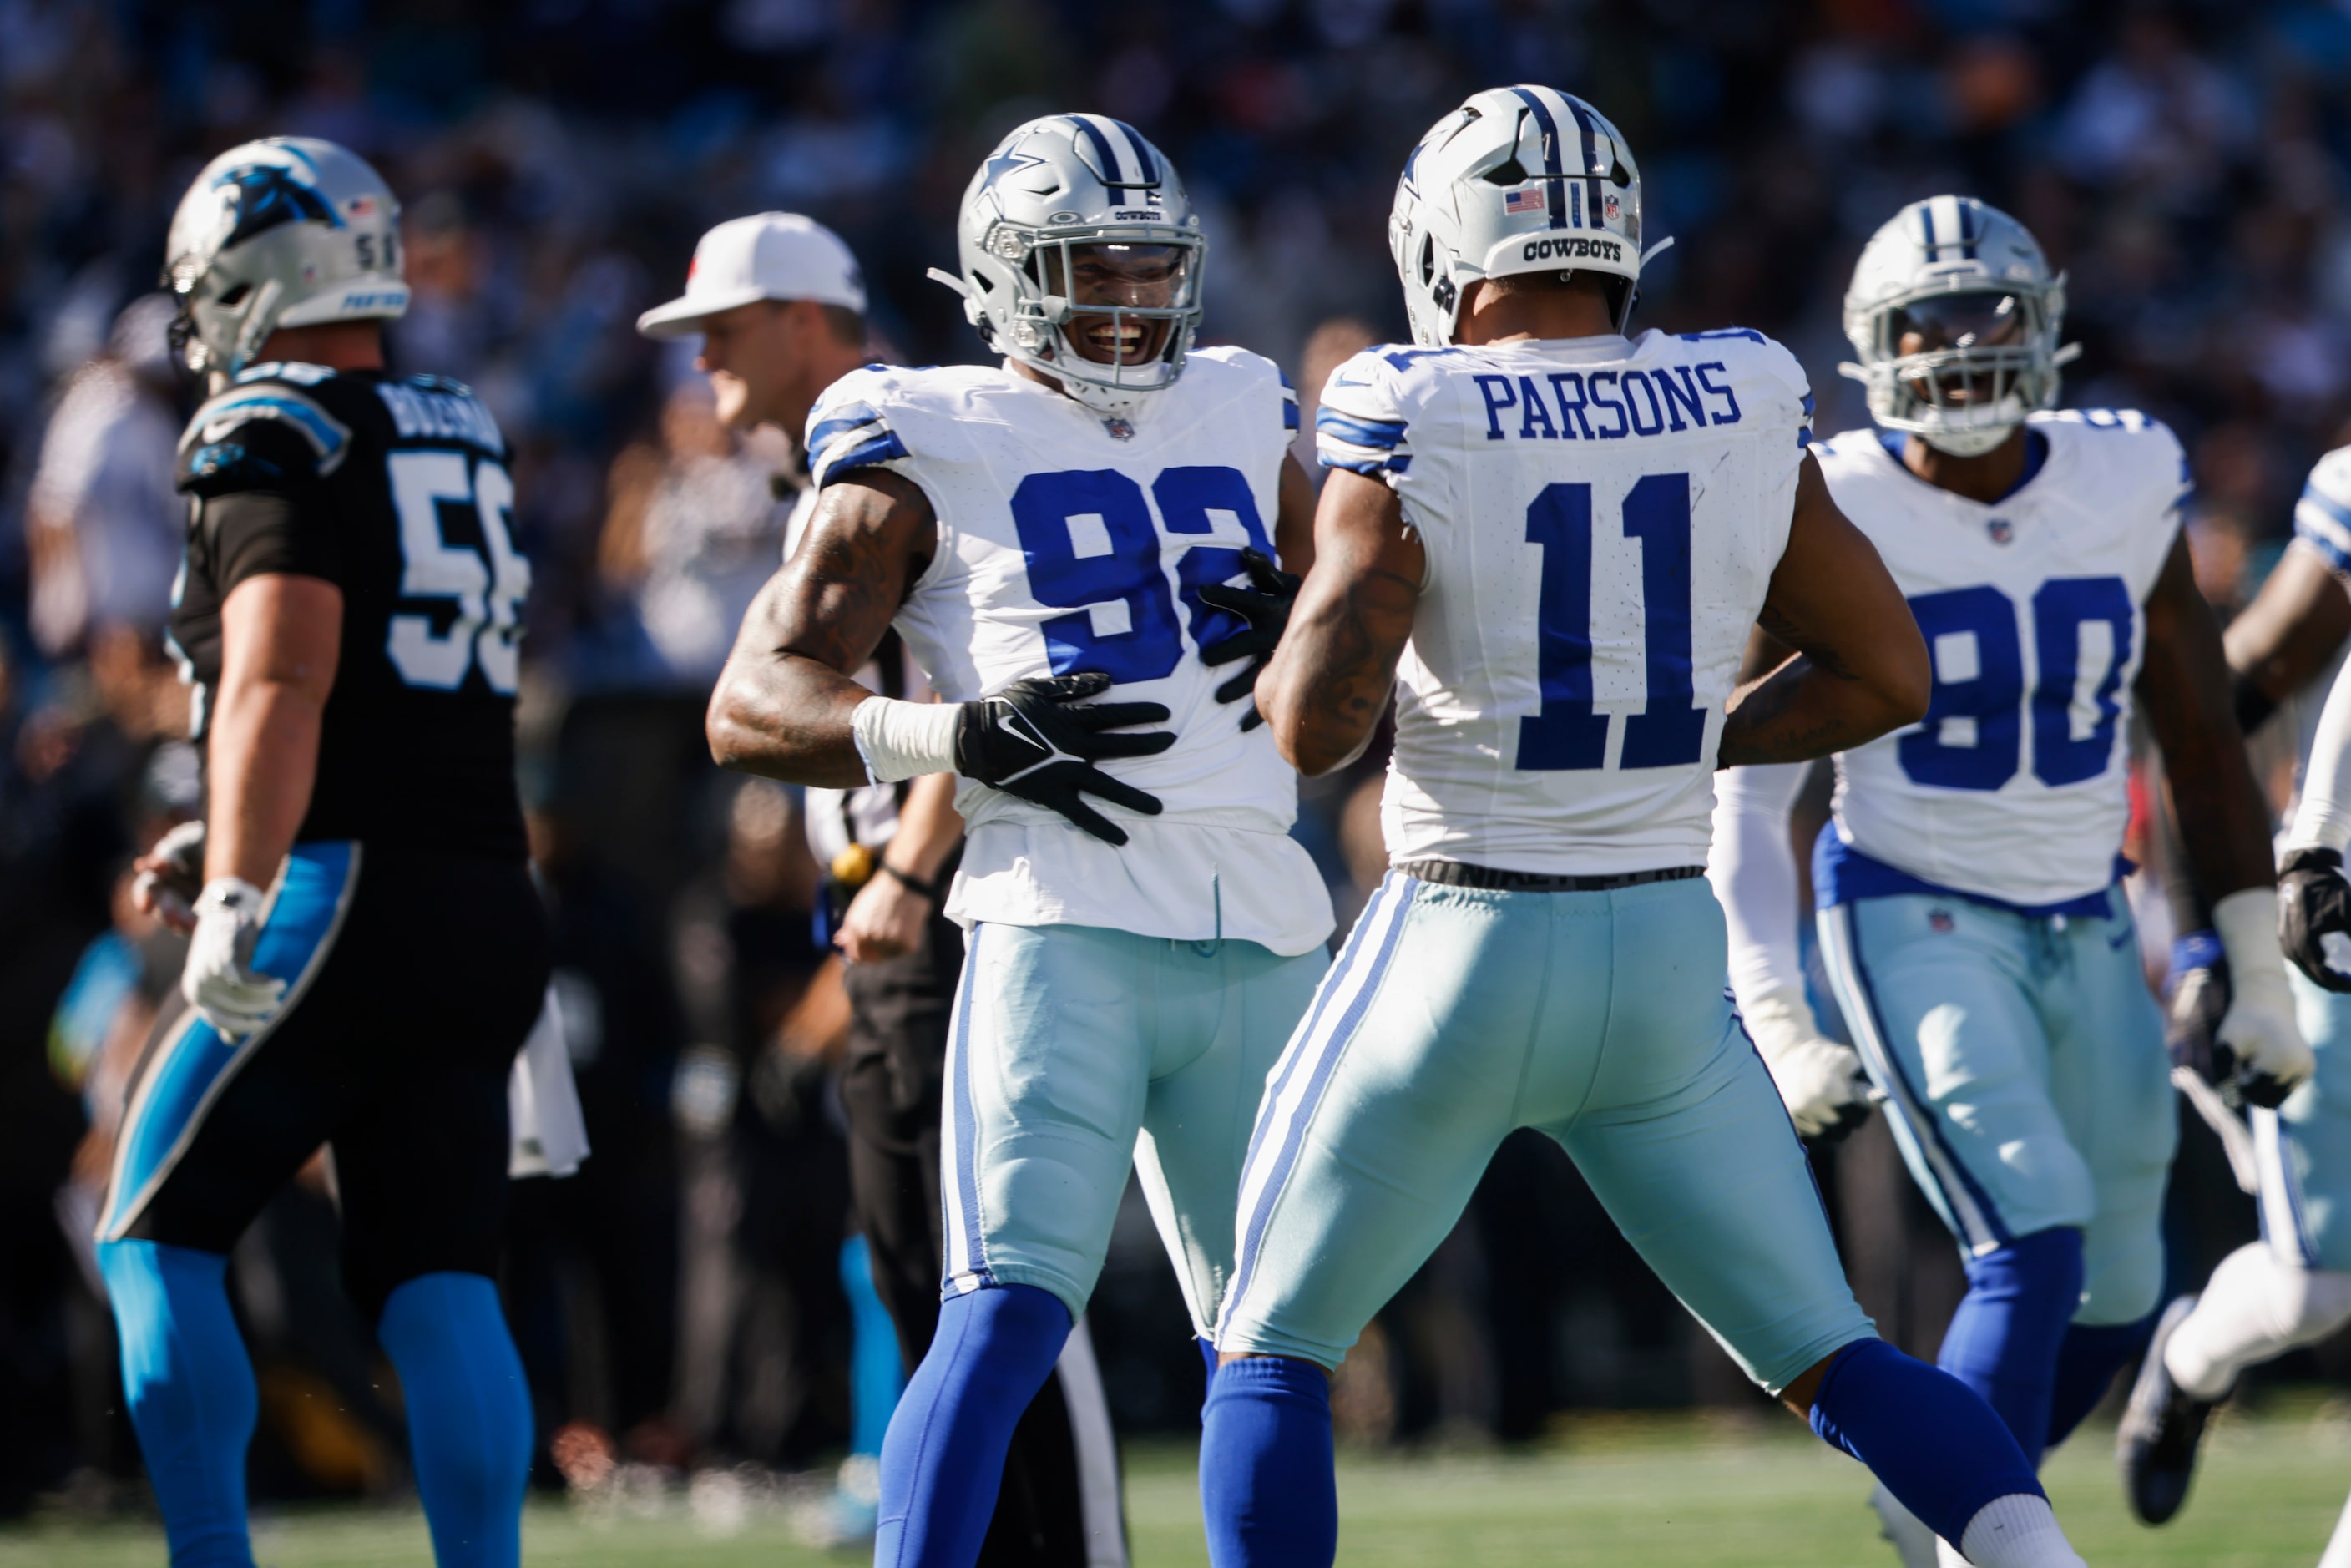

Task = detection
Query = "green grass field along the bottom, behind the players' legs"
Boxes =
[0,1399,2351,1568]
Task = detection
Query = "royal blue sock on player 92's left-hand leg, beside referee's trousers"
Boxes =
[875,1286,1069,1568]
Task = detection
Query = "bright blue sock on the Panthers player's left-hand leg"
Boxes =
[99,1242,259,1568]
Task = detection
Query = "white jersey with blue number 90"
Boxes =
[1813,409,2187,908]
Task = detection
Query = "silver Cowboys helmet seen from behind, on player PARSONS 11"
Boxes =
[1387,87,1641,348]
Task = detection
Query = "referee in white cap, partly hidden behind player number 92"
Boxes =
[637,211,1124,1568]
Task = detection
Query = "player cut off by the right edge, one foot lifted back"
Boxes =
[2116,447,2351,1568]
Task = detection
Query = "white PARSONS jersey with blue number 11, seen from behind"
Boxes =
[1317,329,1813,874]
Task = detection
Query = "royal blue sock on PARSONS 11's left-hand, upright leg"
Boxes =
[1199,1357,1337,1568]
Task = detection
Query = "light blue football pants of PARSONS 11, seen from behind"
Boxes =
[1216,873,1872,1392]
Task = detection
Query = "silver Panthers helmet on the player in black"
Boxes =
[162,136,409,376]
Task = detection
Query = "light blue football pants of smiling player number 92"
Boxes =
[938,924,1328,1338]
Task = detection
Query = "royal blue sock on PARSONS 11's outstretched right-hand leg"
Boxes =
[1813,1340,2048,1540]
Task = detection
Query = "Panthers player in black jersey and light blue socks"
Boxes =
[99,139,548,1568]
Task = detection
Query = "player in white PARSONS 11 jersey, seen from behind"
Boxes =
[1199,87,2081,1568]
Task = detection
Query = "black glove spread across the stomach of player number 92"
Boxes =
[954,670,1176,844]
